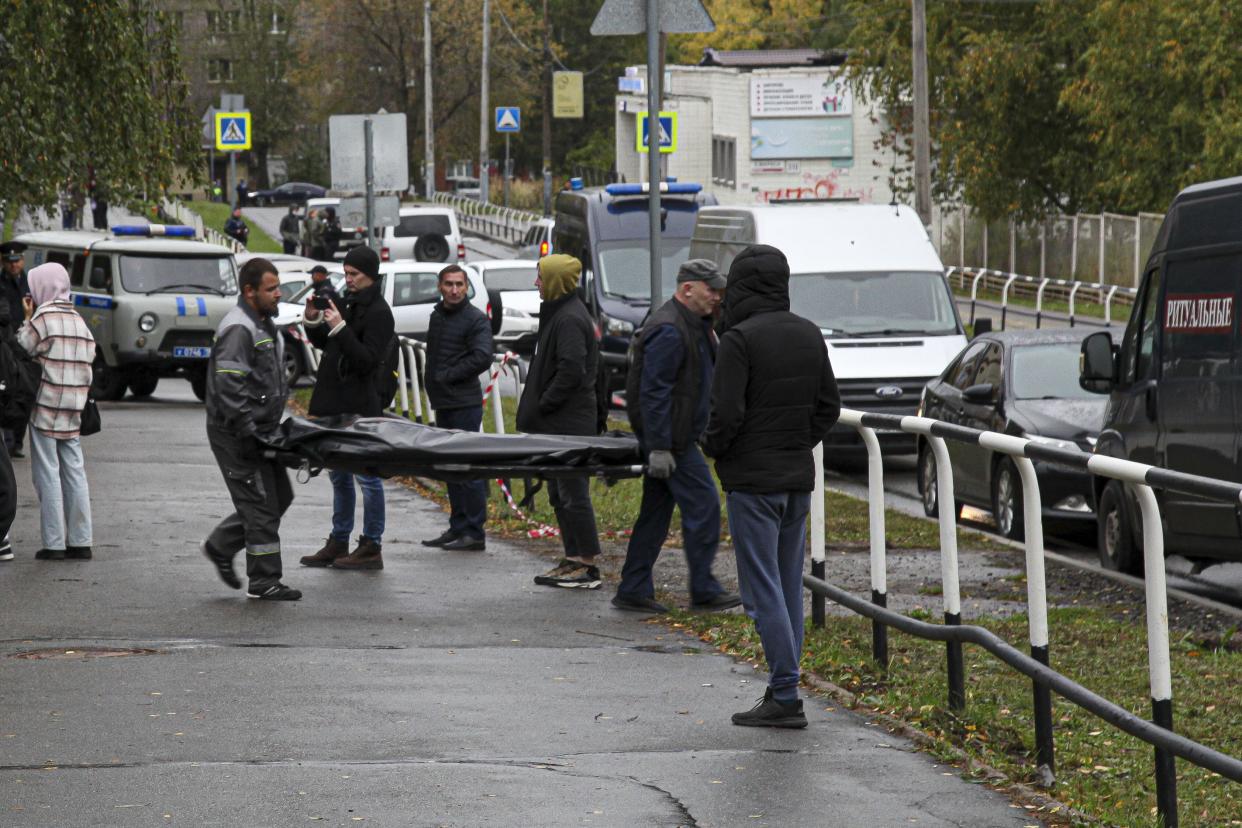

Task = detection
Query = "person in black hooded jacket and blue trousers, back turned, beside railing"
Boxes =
[703,245,841,727]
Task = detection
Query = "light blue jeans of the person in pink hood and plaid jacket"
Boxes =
[30,428,91,549]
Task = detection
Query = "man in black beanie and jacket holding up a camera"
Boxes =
[302,245,394,570]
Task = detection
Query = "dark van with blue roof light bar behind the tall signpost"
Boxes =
[551,182,715,390]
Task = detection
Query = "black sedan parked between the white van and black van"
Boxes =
[918,329,1107,539]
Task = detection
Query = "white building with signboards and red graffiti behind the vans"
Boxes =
[616,50,904,204]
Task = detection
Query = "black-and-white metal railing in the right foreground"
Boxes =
[804,410,1242,828]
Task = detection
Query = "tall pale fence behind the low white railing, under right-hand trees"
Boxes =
[932,207,1164,287]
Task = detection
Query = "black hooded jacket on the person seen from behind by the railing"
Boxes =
[703,245,841,494]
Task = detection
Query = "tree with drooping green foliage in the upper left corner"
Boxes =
[0,0,199,223]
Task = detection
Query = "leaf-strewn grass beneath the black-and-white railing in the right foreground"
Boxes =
[671,608,1242,826]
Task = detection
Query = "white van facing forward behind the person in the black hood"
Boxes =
[691,204,966,457]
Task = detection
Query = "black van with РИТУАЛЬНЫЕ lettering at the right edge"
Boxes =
[1079,178,1242,571]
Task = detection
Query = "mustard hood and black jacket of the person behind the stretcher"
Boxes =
[518,253,600,436]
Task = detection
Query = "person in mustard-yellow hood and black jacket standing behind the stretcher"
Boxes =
[518,253,601,590]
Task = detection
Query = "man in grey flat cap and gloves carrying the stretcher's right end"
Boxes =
[612,258,741,613]
